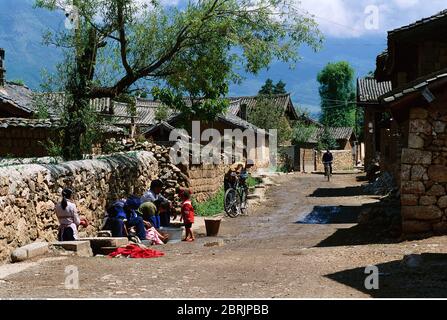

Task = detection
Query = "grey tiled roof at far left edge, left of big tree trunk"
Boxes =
[0,82,33,113]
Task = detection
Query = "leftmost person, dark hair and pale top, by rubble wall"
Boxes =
[55,188,88,241]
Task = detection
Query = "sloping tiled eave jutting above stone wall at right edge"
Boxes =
[380,69,447,103]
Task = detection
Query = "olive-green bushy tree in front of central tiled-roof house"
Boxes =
[248,96,292,145]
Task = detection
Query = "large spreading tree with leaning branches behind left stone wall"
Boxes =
[36,0,322,159]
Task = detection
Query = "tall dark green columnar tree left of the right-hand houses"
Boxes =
[317,61,356,127]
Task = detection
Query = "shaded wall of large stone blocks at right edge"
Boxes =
[401,106,447,235]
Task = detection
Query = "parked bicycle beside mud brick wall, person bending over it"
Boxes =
[224,174,248,218]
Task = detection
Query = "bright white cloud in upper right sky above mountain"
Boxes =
[296,0,447,38]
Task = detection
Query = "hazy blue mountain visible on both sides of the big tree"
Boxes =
[0,0,386,117]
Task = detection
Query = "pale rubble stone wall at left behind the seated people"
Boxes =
[0,151,159,261]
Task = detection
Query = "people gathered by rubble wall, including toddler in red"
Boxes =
[56,180,195,244]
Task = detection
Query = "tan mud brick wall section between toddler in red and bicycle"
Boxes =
[185,164,228,202]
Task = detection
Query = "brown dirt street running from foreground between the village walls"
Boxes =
[0,174,447,298]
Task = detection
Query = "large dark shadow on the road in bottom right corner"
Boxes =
[325,253,447,298]
